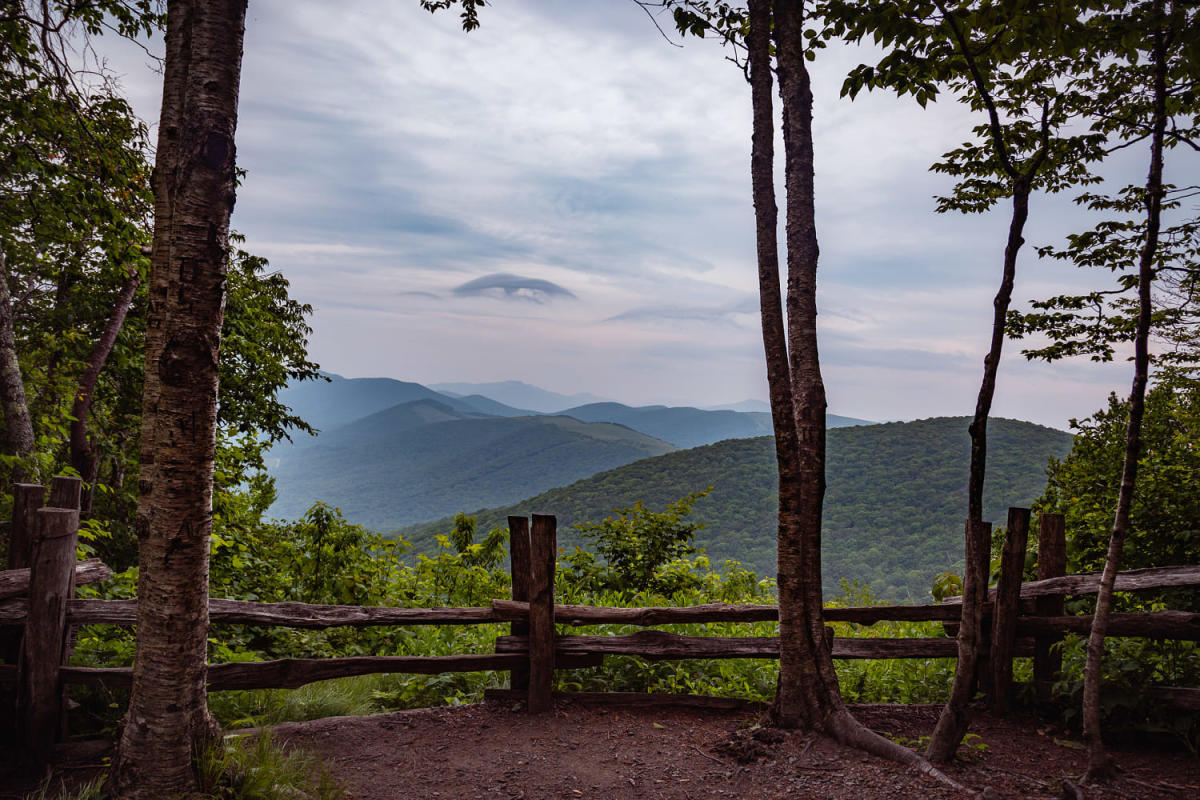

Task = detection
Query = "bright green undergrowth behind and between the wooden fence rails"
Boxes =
[65,506,1200,748]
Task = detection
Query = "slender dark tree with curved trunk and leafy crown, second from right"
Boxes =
[830,0,1104,763]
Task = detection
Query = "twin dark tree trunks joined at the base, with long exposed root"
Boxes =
[748,0,961,789]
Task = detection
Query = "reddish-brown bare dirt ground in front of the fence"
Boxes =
[276,700,1200,800]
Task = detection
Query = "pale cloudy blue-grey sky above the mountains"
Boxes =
[98,0,1198,428]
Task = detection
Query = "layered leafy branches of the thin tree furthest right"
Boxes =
[1012,1,1200,366]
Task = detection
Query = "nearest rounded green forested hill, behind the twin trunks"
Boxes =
[400,417,1072,600]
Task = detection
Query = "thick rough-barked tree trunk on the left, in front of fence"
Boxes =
[113,0,246,799]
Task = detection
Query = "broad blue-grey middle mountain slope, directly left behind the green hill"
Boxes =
[270,399,673,528]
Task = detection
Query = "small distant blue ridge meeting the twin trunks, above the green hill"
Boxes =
[563,403,863,447]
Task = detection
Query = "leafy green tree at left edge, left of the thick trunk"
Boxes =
[0,0,157,489]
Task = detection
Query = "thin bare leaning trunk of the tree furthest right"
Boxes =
[1084,9,1166,784]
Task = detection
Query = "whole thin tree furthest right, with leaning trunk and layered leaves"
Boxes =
[1016,0,1200,783]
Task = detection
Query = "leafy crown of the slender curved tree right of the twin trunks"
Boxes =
[823,0,1104,213]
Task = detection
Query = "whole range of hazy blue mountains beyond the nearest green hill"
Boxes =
[268,374,860,529]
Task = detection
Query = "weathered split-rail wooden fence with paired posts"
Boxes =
[0,479,1200,764]
